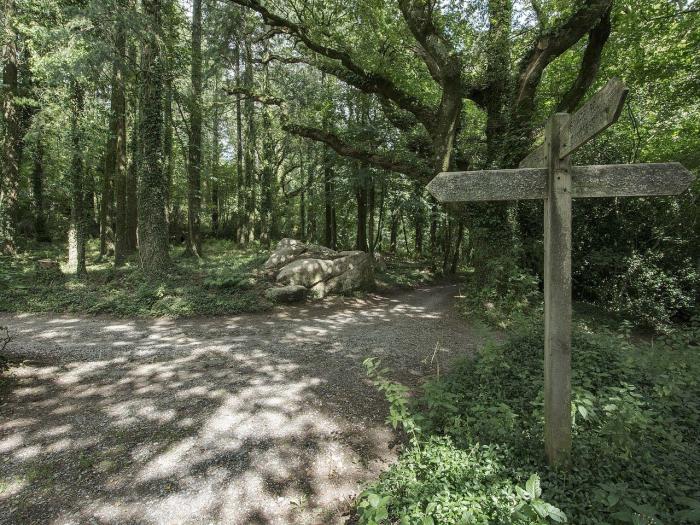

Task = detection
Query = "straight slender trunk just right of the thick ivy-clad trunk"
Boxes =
[185,0,202,257]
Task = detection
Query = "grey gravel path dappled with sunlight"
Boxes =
[0,286,482,524]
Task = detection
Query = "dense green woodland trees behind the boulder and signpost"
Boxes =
[0,0,700,327]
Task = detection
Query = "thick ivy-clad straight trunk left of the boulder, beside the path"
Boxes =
[138,0,169,276]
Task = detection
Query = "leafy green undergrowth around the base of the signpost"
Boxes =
[358,319,700,525]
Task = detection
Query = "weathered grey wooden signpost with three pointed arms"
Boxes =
[428,75,693,467]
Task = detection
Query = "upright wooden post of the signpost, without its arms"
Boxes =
[544,113,572,468]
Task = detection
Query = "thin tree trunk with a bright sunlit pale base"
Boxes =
[68,80,87,278]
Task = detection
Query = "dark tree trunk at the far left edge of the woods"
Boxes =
[0,0,22,255]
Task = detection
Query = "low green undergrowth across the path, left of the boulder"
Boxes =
[0,237,272,317]
